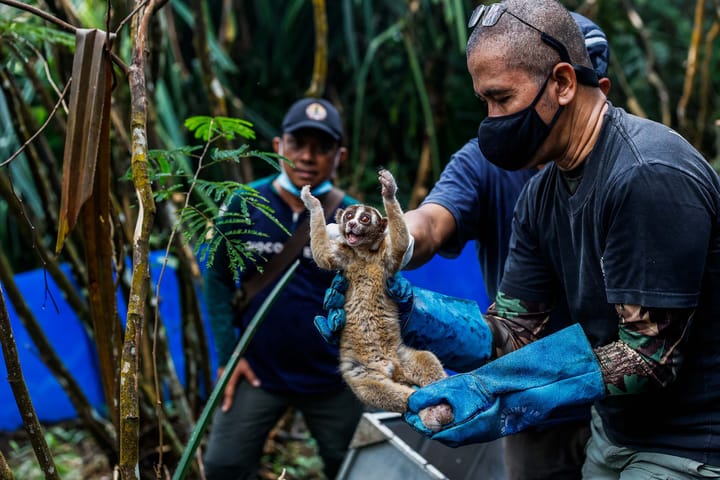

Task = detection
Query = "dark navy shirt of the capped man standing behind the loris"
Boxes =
[205,177,355,394]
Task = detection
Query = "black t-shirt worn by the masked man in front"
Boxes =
[500,106,720,465]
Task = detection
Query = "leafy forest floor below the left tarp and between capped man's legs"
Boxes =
[0,408,324,480]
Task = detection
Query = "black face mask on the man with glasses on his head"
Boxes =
[478,76,563,170]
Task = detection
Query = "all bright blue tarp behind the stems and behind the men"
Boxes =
[0,244,489,431]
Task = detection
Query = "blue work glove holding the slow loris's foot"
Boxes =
[405,324,605,447]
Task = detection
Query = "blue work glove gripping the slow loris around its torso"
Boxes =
[315,273,492,372]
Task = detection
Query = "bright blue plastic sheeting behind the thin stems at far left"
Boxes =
[0,251,217,431]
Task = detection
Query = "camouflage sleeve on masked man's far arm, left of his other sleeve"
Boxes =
[484,292,552,357]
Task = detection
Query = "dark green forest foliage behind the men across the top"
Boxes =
[0,0,718,258]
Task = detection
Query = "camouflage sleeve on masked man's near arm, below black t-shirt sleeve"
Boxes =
[595,305,694,395]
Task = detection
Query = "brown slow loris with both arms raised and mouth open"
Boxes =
[300,170,453,430]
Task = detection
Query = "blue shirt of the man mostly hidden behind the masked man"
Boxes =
[423,138,537,301]
